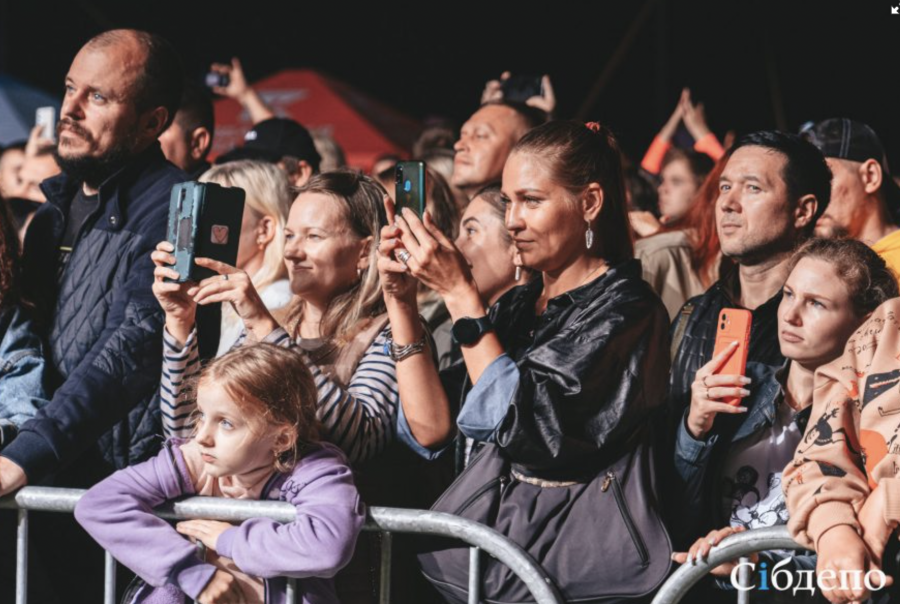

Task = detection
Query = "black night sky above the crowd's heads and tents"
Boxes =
[0,0,900,163]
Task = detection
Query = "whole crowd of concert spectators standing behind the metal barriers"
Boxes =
[0,30,900,604]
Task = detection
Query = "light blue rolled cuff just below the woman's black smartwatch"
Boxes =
[456,354,519,442]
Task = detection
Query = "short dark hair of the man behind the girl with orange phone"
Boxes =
[728,130,831,234]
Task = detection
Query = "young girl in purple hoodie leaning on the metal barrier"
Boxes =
[75,344,365,604]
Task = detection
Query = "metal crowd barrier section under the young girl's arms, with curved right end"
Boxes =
[0,487,563,604]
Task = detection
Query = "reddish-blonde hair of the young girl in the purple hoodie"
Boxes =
[197,344,320,472]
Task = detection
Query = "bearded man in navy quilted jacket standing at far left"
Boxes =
[0,30,187,494]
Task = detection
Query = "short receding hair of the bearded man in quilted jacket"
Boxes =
[87,29,184,132]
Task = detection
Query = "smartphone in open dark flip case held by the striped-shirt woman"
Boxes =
[169,181,244,283]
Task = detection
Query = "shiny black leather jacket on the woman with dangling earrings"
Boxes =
[491,260,669,480]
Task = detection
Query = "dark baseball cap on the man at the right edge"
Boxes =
[800,117,900,216]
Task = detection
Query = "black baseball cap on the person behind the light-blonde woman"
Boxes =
[216,117,322,172]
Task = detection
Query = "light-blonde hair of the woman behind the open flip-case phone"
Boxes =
[200,159,293,289]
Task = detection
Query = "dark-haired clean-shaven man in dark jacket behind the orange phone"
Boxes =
[669,131,831,543]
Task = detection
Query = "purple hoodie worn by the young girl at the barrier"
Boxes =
[75,439,365,604]
